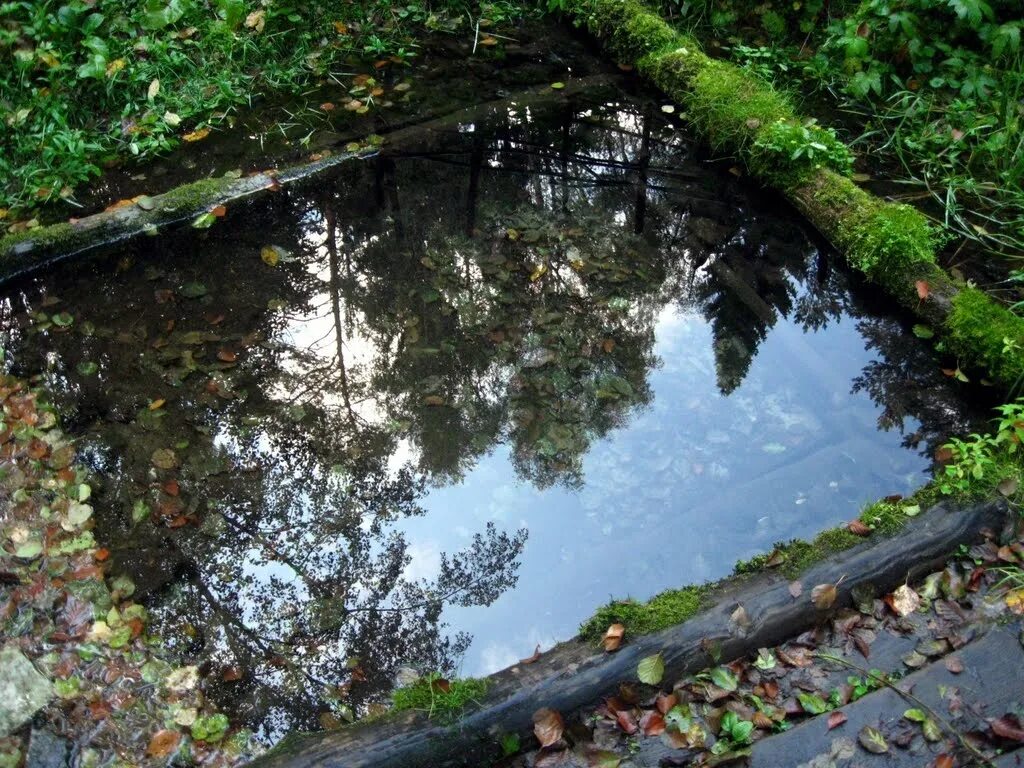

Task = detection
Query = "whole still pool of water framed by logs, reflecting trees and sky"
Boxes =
[2,87,978,739]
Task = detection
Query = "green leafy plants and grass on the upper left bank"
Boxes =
[0,0,527,215]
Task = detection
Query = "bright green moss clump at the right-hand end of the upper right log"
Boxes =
[945,287,1024,386]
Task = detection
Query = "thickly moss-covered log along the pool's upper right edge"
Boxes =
[566,0,1024,388]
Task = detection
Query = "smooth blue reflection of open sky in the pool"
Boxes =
[402,296,927,675]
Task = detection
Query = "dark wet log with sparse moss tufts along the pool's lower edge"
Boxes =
[253,500,1010,768]
